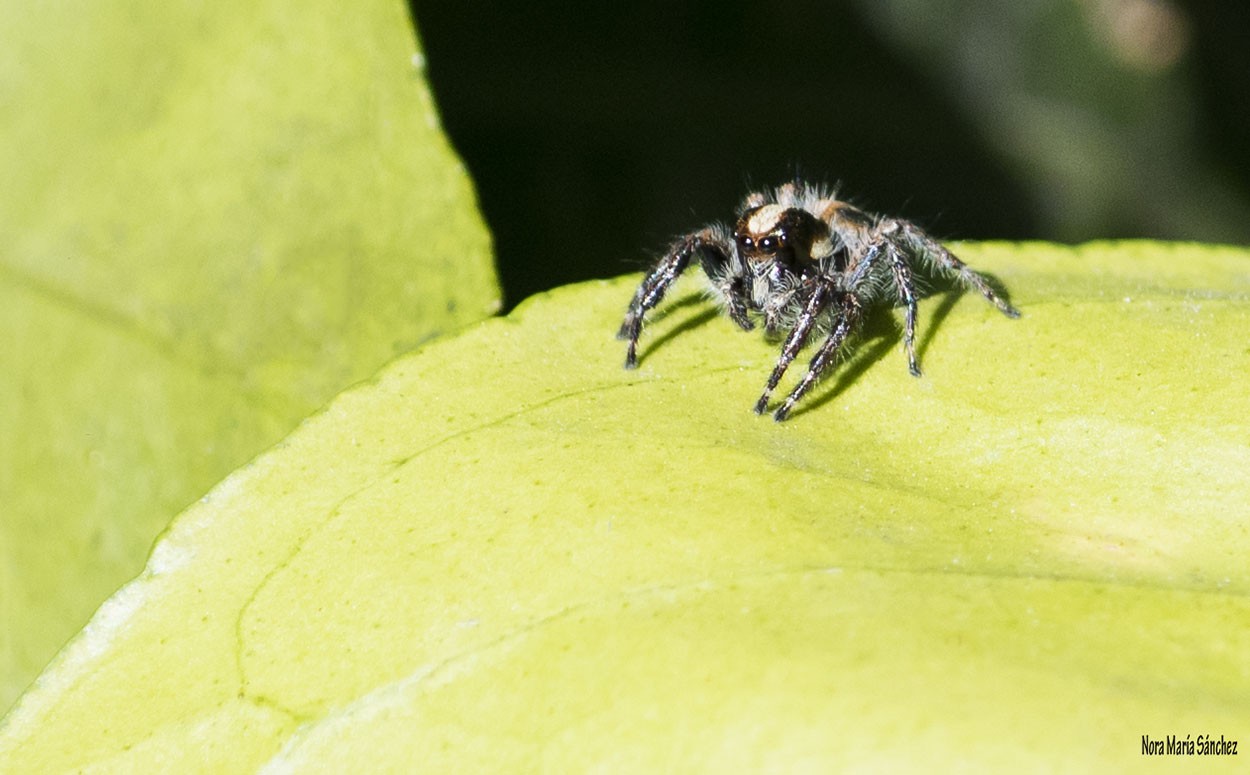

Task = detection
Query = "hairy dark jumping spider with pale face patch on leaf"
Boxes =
[618,181,1020,423]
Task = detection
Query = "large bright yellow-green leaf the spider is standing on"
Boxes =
[0,243,1250,771]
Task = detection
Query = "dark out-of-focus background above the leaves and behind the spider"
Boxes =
[413,0,1250,308]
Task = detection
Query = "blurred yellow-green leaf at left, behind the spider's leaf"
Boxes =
[0,0,499,709]
